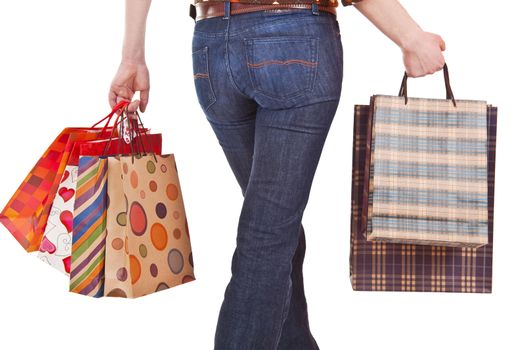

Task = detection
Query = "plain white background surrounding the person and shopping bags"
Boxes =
[0,0,525,350]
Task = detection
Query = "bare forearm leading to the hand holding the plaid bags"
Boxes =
[354,0,423,50]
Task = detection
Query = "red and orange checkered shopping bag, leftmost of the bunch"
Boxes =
[0,101,129,252]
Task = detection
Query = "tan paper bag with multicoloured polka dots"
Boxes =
[104,154,195,298]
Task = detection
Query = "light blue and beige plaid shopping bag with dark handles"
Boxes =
[363,65,488,247]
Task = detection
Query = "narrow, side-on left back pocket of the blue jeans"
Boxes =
[192,46,217,110]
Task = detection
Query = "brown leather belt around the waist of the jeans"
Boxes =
[195,2,336,21]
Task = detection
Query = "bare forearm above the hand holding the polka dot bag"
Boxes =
[122,0,151,62]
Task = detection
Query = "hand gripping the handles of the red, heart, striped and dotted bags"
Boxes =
[109,60,150,112]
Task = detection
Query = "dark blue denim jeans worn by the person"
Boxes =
[192,4,343,350]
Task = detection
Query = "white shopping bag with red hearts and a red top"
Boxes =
[38,130,162,275]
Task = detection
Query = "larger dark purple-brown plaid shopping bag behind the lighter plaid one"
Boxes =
[350,92,497,293]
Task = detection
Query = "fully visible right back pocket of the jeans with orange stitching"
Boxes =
[244,36,318,100]
